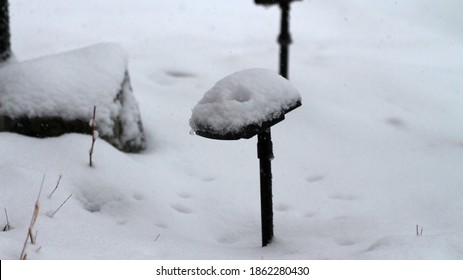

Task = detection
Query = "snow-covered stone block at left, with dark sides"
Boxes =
[0,44,145,152]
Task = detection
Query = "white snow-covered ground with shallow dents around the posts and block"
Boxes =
[0,0,463,259]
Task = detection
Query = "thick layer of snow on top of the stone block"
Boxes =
[0,44,127,122]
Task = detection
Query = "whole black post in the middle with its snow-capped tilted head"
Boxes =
[190,69,301,246]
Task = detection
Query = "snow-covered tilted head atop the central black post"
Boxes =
[190,69,301,140]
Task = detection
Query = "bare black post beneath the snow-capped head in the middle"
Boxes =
[257,128,273,247]
